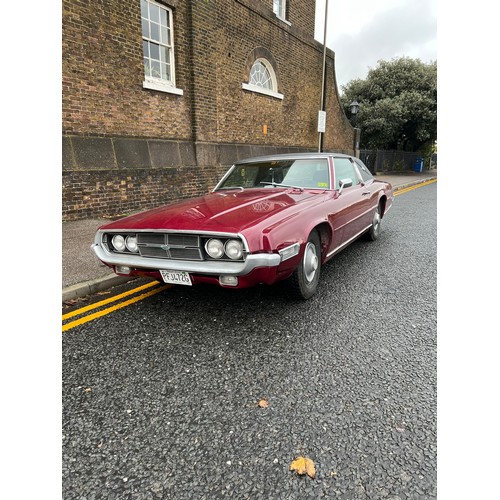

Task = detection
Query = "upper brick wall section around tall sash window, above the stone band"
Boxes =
[62,0,192,139]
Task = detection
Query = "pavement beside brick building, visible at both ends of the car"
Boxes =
[62,170,437,302]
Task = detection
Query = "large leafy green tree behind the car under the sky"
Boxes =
[341,57,437,151]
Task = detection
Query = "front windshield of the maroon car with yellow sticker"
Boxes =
[217,158,330,190]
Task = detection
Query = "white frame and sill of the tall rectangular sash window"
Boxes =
[141,0,184,95]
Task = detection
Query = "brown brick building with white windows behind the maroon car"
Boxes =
[62,0,354,220]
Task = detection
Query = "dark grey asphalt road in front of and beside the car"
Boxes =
[62,184,437,500]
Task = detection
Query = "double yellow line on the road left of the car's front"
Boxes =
[62,281,172,332]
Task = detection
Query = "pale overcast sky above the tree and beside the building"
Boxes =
[315,0,437,92]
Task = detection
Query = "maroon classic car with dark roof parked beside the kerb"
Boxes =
[92,153,394,299]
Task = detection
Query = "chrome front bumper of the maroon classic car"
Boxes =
[90,242,281,276]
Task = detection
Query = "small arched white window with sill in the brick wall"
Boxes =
[242,51,284,99]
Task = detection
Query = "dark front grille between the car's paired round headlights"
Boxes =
[137,233,203,260]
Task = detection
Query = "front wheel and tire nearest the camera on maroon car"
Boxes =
[289,231,321,299]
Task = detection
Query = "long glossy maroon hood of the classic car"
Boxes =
[100,188,324,233]
